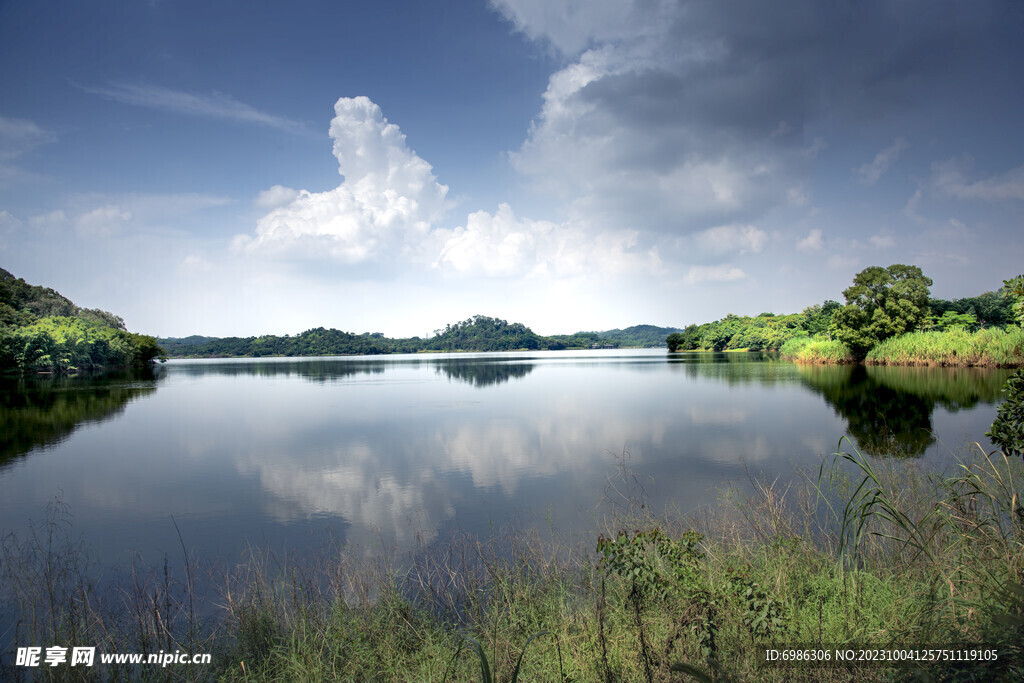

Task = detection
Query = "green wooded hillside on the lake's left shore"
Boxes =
[0,268,162,373]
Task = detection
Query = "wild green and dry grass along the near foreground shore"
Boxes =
[0,449,1024,681]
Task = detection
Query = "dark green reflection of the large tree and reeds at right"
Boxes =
[798,366,1009,457]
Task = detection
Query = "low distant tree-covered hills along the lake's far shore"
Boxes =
[158,315,679,357]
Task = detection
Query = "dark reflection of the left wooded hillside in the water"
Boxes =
[0,372,157,468]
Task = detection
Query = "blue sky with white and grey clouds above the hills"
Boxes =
[0,0,1024,337]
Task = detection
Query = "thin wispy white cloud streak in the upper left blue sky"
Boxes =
[77,83,309,134]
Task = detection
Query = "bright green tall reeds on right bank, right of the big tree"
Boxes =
[865,326,1024,368]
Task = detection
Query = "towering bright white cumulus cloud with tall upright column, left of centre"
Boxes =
[233,97,447,264]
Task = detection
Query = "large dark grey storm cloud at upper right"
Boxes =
[501,0,1024,231]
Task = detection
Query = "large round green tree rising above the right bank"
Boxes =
[833,263,932,358]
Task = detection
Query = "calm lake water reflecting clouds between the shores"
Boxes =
[0,349,1009,565]
